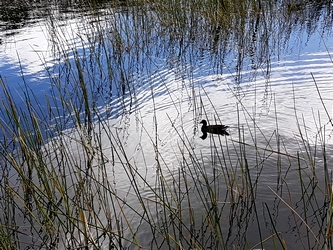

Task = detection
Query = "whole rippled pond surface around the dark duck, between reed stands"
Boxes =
[0,0,333,249]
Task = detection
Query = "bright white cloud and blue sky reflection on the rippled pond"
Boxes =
[0,1,333,248]
